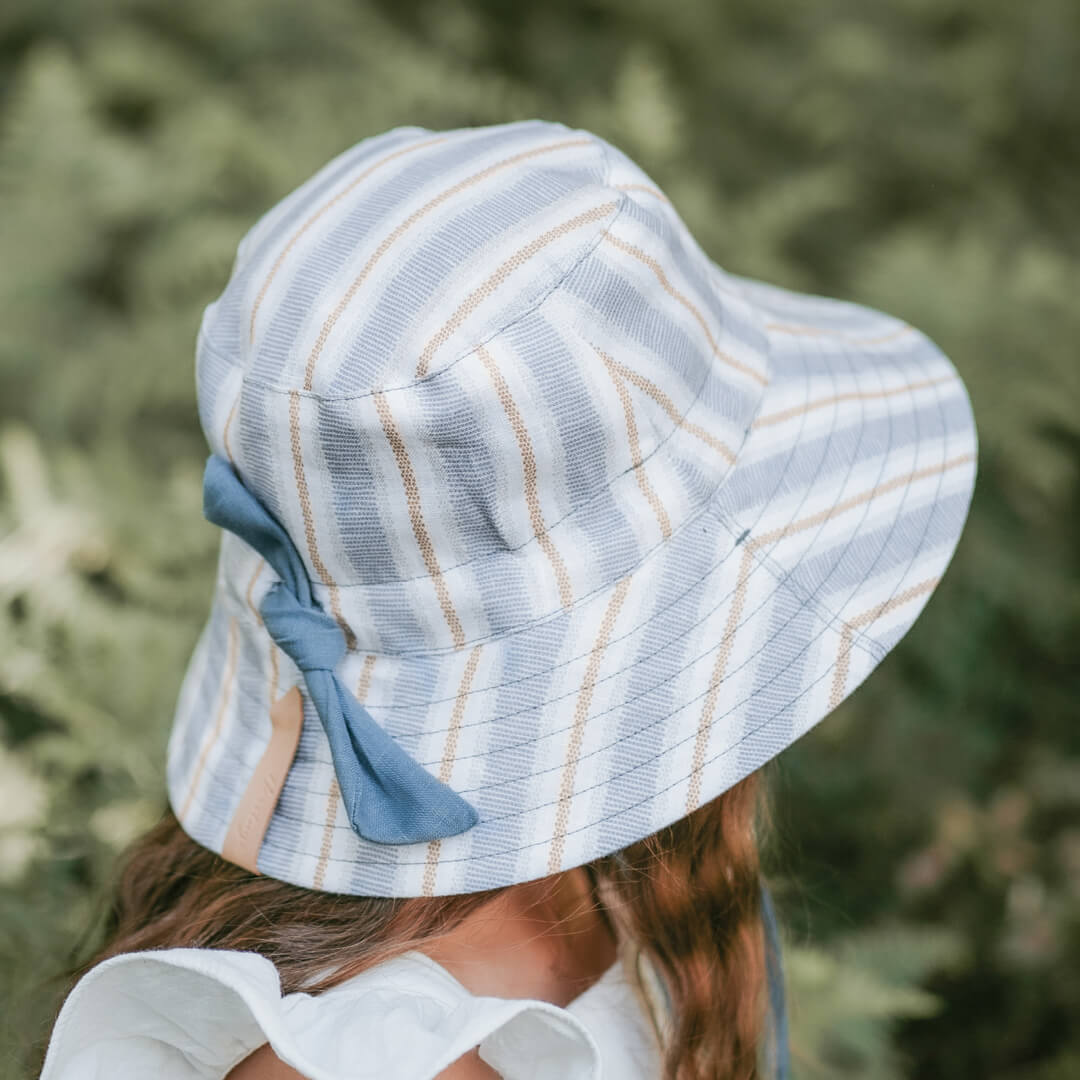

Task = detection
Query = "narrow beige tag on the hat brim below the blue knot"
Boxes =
[221,686,303,874]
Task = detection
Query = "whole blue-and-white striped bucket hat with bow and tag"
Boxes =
[167,121,975,896]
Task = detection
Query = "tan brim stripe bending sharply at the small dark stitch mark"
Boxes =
[686,454,974,813]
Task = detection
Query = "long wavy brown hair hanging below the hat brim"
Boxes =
[50,770,770,1080]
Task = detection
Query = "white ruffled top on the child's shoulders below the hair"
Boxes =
[41,948,660,1080]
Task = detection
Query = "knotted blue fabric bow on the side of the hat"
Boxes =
[203,454,480,843]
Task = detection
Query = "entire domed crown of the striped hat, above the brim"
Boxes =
[198,122,768,652]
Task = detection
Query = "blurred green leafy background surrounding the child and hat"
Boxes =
[0,0,1080,1080]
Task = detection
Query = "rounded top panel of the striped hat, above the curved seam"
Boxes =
[203,122,618,396]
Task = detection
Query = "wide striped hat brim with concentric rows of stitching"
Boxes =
[171,266,976,896]
